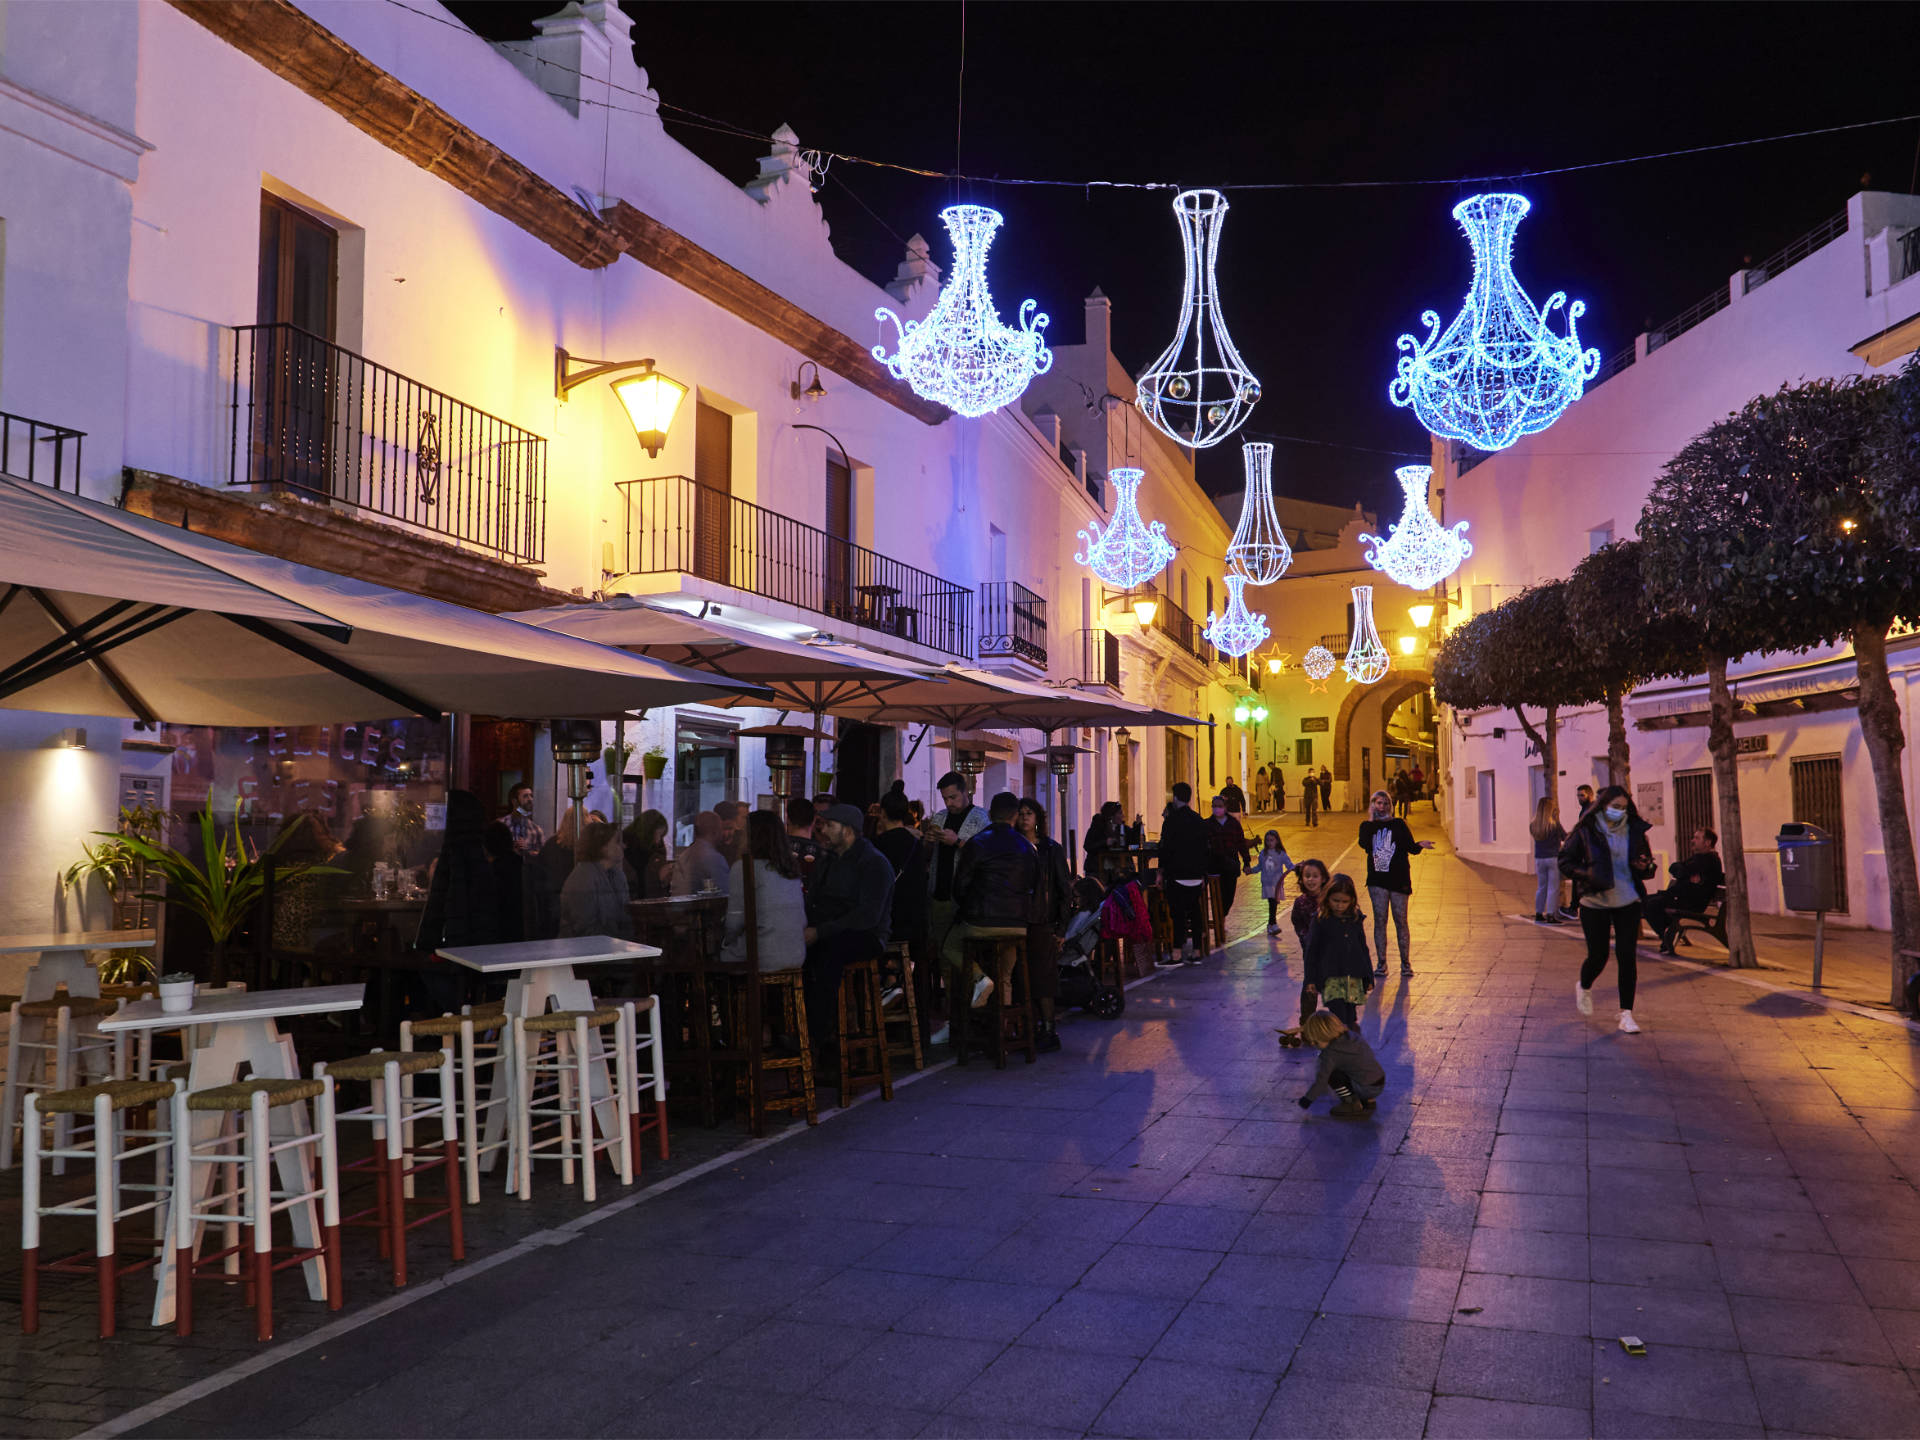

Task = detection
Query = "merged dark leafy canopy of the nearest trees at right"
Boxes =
[1640,376,1920,659]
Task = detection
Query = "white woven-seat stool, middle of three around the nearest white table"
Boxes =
[173,1077,342,1340]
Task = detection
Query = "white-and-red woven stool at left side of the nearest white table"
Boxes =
[19,1081,177,1340]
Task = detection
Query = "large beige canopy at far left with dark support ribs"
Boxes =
[0,476,760,726]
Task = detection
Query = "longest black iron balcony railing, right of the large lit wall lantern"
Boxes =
[618,474,975,660]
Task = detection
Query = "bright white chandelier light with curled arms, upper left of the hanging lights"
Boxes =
[874,205,1054,419]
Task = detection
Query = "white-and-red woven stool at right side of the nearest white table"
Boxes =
[313,1046,467,1288]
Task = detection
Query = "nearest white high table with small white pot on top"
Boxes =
[100,985,365,1325]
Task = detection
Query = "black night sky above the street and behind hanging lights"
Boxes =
[451,0,1920,511]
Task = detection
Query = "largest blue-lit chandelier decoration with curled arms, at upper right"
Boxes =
[1386,194,1599,451]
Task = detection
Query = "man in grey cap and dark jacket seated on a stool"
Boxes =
[801,804,893,1060]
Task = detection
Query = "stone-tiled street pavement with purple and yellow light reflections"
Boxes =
[52,814,1920,1436]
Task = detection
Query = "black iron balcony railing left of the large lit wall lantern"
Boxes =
[227,324,547,564]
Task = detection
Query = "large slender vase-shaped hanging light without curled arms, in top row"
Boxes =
[1135,190,1265,445]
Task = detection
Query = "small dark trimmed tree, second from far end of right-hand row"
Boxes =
[1567,540,1699,793]
